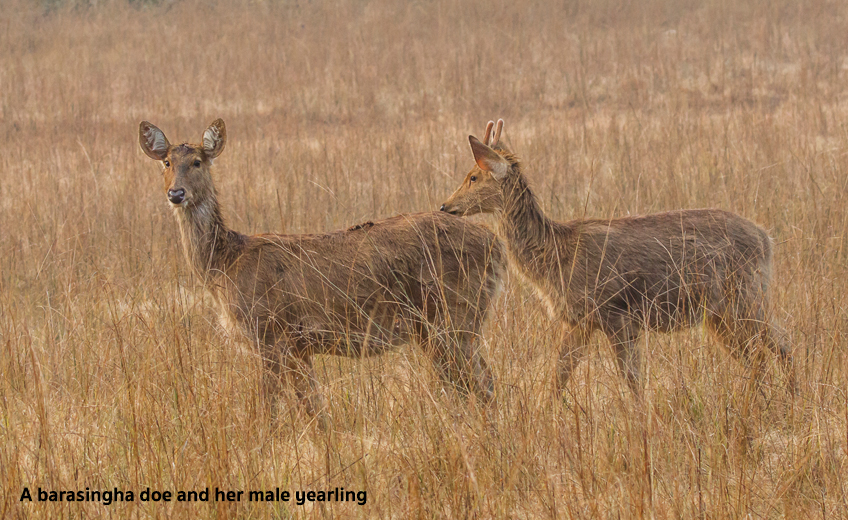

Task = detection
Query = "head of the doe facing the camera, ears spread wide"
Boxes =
[138,119,227,208]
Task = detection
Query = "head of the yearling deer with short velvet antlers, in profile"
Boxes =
[441,119,513,216]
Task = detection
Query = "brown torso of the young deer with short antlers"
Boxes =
[548,210,771,331]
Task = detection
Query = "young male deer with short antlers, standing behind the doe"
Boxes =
[441,120,794,394]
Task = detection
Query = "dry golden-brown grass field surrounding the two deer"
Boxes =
[0,0,848,518]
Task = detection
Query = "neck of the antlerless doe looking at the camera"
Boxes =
[174,195,244,281]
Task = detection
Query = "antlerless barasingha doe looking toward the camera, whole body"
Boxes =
[139,119,505,427]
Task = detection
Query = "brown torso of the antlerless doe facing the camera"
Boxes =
[221,213,503,355]
